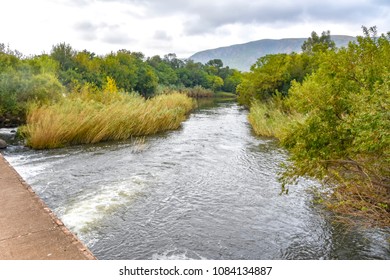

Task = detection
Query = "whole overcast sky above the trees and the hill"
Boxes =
[0,0,390,58]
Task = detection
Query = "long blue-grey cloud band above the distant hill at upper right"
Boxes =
[181,1,383,35]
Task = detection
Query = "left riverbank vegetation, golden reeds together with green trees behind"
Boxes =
[0,43,241,149]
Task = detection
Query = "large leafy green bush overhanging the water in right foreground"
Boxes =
[281,28,390,226]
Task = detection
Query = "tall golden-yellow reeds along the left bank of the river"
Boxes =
[23,93,194,149]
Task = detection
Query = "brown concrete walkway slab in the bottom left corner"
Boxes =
[0,154,95,260]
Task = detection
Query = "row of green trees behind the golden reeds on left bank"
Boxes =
[0,42,241,126]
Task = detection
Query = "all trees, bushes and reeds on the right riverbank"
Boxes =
[237,27,390,226]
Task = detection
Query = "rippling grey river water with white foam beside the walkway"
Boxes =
[4,100,390,259]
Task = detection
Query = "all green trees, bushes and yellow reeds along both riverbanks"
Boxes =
[0,27,390,226]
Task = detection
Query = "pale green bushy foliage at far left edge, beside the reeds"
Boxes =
[0,47,64,125]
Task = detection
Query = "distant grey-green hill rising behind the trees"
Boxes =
[190,35,356,71]
